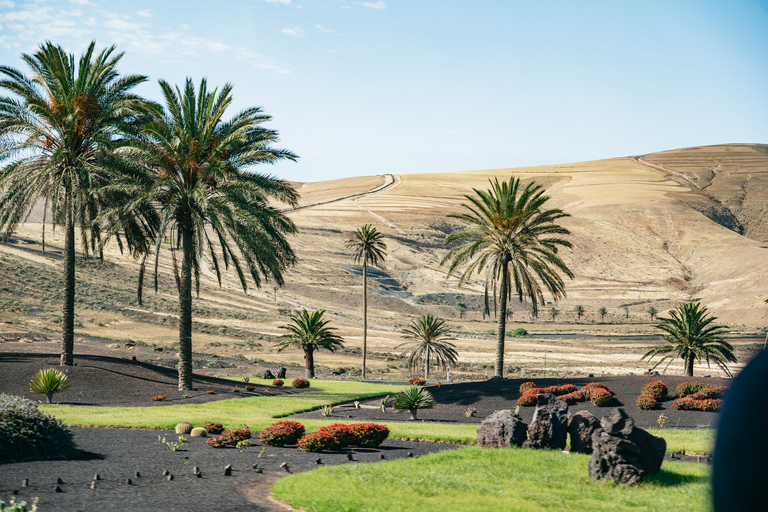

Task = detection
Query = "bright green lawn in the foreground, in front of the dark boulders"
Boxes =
[272,447,710,512]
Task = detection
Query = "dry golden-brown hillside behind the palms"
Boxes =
[0,144,768,373]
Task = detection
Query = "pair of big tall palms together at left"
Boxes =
[0,42,298,389]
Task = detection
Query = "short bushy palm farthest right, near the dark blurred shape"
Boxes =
[641,303,737,377]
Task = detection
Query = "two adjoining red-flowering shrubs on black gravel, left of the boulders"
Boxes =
[259,420,389,452]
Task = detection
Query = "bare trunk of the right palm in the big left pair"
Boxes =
[179,226,193,390]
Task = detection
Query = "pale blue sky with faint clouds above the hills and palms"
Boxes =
[0,0,768,181]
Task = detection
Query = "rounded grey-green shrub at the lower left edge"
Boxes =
[0,394,76,460]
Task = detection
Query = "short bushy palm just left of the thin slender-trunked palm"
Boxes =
[277,309,344,379]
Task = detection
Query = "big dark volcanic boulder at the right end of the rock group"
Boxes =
[589,408,667,485]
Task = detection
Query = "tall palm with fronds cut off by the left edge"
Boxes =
[0,42,147,366]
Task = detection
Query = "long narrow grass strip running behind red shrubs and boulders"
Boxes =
[40,380,714,453]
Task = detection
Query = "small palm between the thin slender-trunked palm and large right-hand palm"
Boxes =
[395,314,459,380]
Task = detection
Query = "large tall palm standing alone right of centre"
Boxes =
[441,177,573,377]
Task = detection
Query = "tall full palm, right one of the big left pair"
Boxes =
[111,79,298,389]
